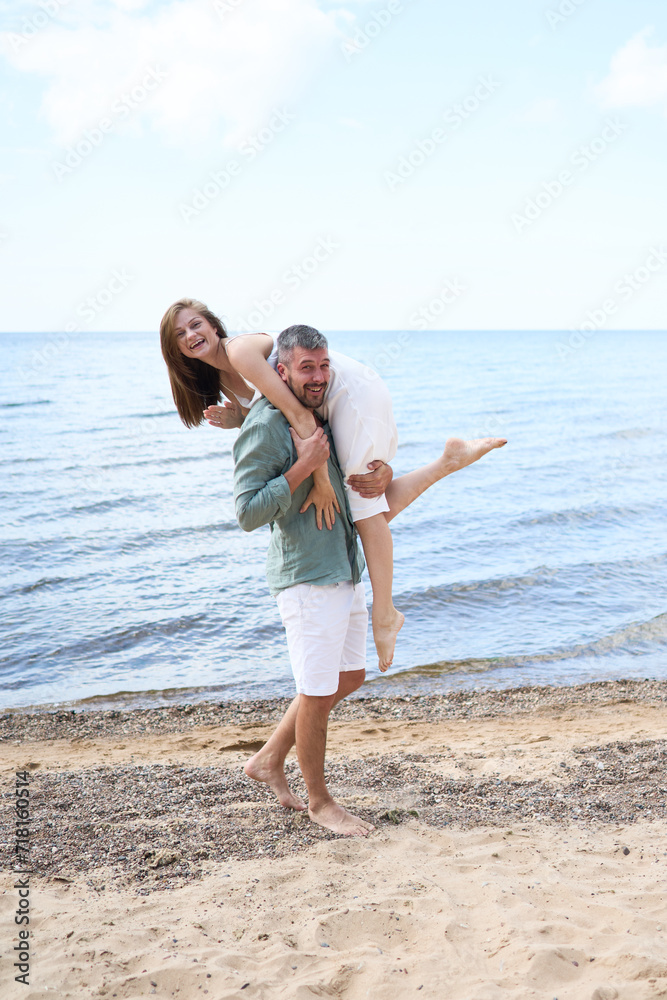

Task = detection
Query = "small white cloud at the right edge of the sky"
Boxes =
[596,28,667,114]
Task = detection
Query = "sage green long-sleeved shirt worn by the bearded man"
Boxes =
[234,399,364,594]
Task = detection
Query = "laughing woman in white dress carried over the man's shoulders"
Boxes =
[160,299,505,671]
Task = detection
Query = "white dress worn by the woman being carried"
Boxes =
[231,337,398,521]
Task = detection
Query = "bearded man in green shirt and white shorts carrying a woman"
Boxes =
[234,326,380,836]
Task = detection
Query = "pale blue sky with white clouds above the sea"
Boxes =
[0,0,667,333]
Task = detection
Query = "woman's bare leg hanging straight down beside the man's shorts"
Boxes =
[355,512,405,672]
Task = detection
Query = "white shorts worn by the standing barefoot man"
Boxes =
[276,580,368,697]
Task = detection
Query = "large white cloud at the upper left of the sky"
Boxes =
[0,0,339,146]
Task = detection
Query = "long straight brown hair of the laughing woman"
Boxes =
[160,299,227,427]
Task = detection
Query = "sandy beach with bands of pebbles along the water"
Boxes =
[0,681,667,1000]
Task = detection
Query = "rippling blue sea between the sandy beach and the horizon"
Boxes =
[0,330,667,710]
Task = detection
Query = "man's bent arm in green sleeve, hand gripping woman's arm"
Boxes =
[234,423,329,531]
